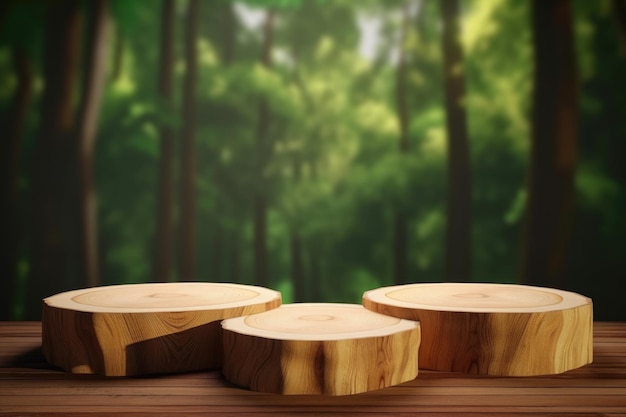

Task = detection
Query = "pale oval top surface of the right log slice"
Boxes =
[363,283,591,313]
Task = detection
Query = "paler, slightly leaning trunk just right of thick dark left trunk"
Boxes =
[76,0,111,287]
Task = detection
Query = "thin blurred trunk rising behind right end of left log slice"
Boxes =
[254,10,274,286]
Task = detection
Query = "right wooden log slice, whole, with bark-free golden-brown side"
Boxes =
[363,283,593,376]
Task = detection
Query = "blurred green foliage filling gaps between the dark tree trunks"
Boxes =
[0,0,626,318]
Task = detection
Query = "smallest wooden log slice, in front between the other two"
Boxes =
[222,303,420,395]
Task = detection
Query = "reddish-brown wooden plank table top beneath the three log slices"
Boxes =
[0,322,626,417]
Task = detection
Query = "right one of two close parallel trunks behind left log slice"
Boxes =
[180,0,200,280]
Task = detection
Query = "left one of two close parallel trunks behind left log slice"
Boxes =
[152,0,175,282]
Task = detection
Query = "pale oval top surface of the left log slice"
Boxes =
[44,282,280,313]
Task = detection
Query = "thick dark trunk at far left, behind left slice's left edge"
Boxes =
[26,0,81,319]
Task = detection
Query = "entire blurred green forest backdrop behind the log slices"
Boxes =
[0,0,626,320]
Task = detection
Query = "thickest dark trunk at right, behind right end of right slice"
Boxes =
[521,0,578,286]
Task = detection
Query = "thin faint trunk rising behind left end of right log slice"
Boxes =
[393,2,410,284]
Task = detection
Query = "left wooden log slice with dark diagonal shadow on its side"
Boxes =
[42,282,281,376]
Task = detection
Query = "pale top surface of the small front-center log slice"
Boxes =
[222,303,418,340]
